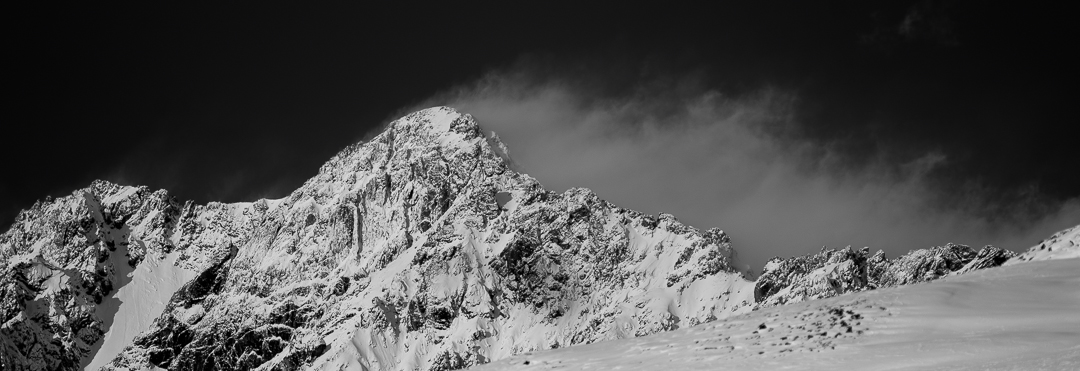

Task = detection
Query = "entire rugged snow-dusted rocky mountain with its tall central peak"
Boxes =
[0,107,1058,370]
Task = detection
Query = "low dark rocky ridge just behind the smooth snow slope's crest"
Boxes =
[754,244,1015,306]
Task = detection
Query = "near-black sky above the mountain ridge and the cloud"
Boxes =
[0,1,1080,266]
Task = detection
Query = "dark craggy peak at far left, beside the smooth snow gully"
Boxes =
[0,181,190,370]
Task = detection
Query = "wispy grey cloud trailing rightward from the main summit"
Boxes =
[408,63,1080,270]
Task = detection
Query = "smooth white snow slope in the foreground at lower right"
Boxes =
[477,259,1080,370]
